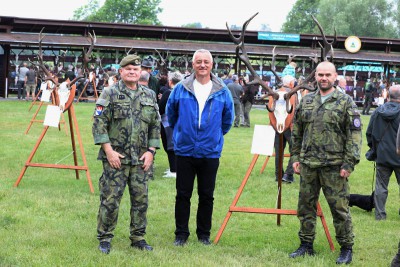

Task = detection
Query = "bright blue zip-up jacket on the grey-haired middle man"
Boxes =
[166,73,235,158]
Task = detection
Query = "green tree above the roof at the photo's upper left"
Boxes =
[74,0,162,25]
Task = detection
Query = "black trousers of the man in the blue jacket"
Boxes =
[175,156,219,238]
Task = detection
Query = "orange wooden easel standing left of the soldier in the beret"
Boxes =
[14,85,94,193]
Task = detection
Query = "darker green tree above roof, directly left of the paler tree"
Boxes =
[281,0,320,34]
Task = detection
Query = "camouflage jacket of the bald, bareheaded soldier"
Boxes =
[290,90,362,172]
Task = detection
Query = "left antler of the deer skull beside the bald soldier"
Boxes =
[226,12,279,112]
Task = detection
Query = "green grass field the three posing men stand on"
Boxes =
[0,101,400,267]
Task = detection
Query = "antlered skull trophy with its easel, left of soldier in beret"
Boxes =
[14,29,94,193]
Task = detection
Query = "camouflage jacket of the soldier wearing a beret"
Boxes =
[92,81,160,165]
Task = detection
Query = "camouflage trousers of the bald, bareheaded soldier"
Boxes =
[297,164,354,246]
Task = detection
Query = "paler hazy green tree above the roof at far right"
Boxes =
[317,0,397,38]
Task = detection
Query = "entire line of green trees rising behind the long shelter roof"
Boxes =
[72,0,400,38]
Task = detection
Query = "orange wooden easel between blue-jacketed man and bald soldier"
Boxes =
[214,134,335,251]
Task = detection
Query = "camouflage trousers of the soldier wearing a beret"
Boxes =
[97,162,150,242]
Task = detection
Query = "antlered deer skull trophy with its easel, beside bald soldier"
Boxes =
[214,13,336,250]
